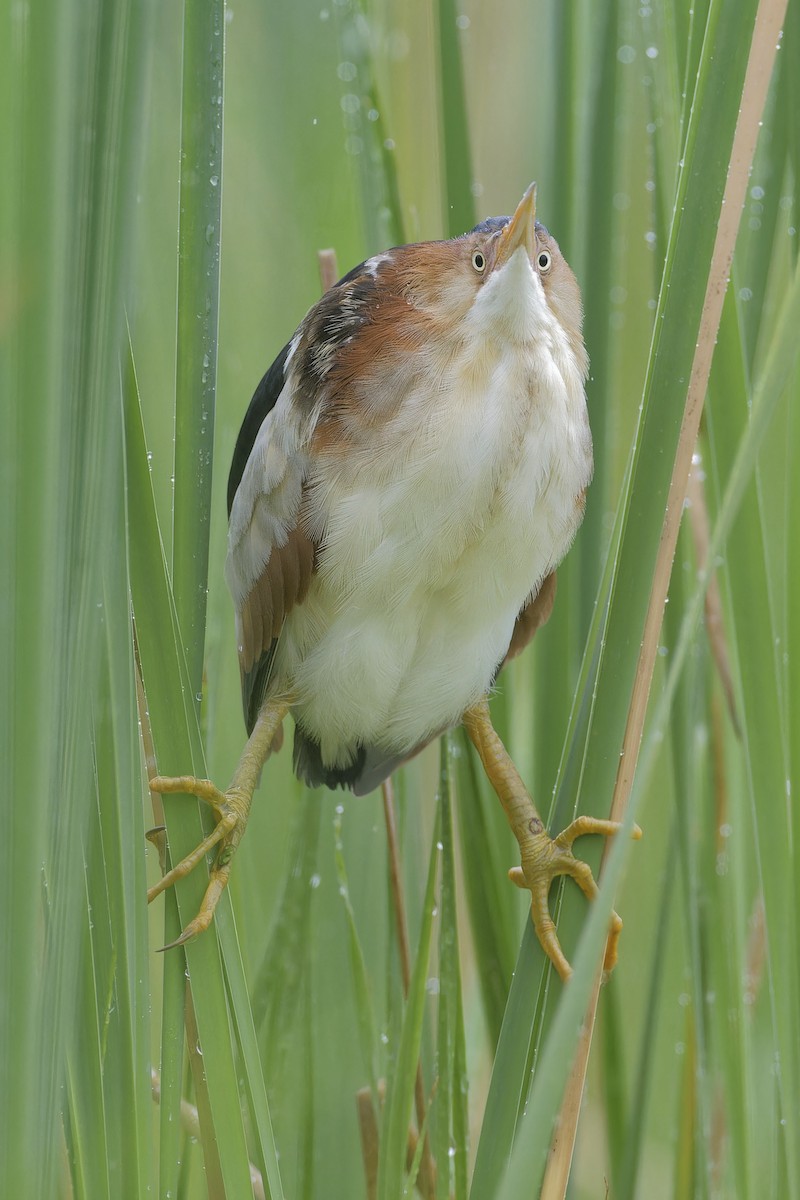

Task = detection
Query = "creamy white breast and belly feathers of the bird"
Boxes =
[281,328,591,761]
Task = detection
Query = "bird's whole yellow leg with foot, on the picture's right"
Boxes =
[463,700,642,980]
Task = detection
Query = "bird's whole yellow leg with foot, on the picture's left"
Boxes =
[148,697,289,950]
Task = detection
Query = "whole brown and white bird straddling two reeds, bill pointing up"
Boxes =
[149,184,638,980]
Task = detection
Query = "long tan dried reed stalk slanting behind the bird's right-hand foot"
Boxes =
[541,0,787,1200]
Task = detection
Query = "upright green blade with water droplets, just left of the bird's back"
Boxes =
[173,0,225,704]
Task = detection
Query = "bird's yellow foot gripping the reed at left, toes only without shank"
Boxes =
[148,775,252,950]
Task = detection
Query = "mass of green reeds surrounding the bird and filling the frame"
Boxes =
[0,0,800,1200]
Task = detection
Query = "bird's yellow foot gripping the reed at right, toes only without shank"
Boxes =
[509,816,642,982]
